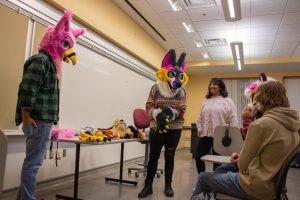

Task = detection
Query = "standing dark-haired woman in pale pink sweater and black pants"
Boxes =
[195,78,238,173]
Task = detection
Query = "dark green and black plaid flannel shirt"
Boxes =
[15,51,59,126]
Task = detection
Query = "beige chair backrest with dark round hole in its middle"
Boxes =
[213,126,244,156]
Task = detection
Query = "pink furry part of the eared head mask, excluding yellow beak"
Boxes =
[39,10,85,73]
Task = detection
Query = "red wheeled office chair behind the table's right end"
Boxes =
[128,108,163,178]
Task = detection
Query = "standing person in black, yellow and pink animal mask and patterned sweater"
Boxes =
[138,49,188,198]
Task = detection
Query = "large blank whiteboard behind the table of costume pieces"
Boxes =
[59,44,154,130]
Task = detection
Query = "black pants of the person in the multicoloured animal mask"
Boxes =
[145,129,181,185]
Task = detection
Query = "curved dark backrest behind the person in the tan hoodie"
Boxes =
[275,144,300,200]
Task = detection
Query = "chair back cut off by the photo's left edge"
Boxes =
[0,129,7,194]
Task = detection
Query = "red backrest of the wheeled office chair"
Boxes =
[133,108,151,129]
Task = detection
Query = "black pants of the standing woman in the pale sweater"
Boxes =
[195,137,219,174]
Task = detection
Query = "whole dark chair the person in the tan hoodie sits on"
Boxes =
[216,144,300,200]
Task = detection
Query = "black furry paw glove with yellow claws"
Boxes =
[156,107,174,133]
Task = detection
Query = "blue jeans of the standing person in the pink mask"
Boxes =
[18,121,52,200]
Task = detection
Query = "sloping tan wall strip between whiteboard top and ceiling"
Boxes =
[46,0,166,68]
